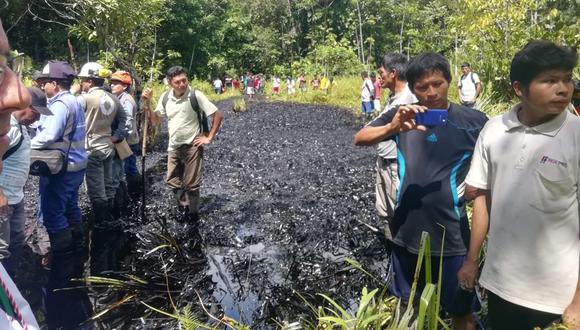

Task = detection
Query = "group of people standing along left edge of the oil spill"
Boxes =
[0,16,223,329]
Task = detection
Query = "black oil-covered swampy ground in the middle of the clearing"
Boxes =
[19,101,386,329]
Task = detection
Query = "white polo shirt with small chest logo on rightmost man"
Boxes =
[465,105,580,314]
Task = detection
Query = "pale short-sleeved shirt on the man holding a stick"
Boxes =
[155,87,218,151]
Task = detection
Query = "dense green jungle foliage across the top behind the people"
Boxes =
[0,0,580,100]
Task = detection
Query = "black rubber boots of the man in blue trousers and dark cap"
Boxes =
[45,228,92,330]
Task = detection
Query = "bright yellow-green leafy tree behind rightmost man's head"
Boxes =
[450,0,580,99]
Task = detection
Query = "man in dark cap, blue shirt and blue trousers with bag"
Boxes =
[31,61,92,329]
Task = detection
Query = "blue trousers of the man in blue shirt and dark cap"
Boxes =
[39,170,85,233]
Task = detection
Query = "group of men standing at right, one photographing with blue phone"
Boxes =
[355,41,580,330]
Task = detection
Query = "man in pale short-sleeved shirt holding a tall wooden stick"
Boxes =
[142,66,222,224]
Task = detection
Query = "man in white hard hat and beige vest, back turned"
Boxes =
[78,62,130,274]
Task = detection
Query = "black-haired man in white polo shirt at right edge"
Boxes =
[458,41,580,330]
